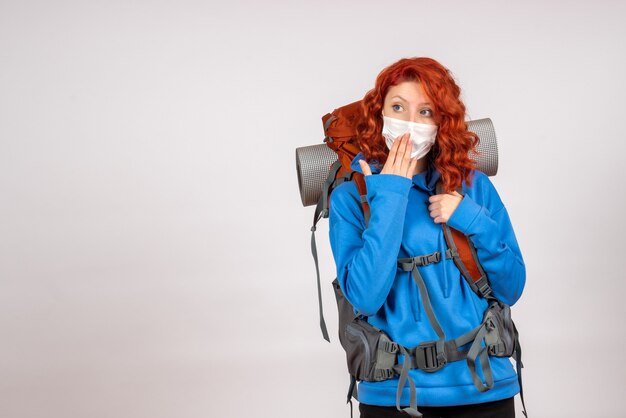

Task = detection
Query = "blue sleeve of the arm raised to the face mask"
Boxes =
[329,174,412,316]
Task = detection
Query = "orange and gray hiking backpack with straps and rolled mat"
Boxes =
[296,101,528,418]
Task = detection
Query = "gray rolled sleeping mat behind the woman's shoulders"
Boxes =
[296,118,498,206]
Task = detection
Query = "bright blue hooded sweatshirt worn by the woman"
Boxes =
[329,154,526,406]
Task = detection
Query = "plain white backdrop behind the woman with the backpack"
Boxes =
[0,0,626,418]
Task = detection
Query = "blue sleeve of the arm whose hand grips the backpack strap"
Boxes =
[448,173,526,305]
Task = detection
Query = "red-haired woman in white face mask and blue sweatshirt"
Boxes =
[329,58,526,418]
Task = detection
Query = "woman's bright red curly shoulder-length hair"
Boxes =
[356,58,479,193]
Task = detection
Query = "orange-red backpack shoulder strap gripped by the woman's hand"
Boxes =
[436,180,495,300]
